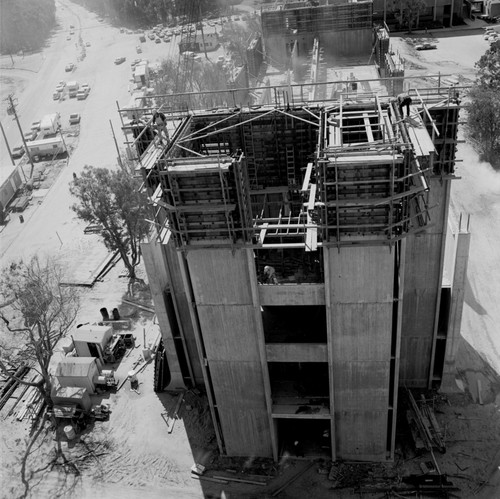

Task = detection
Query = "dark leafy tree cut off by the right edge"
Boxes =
[466,42,500,168]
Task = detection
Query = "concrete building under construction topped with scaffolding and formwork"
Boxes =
[121,2,469,461]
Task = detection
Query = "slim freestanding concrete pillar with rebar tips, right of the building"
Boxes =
[441,231,470,392]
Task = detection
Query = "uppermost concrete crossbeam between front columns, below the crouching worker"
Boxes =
[259,284,325,306]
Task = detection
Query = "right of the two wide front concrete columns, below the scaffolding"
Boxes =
[325,245,394,461]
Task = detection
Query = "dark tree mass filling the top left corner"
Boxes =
[0,0,56,54]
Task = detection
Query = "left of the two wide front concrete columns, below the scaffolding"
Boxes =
[186,248,273,457]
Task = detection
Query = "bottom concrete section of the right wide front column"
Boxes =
[335,411,387,461]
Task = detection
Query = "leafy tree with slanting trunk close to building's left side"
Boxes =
[70,162,150,279]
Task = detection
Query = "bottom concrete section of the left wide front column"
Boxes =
[208,360,272,457]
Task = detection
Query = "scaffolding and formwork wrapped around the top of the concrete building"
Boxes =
[121,81,459,252]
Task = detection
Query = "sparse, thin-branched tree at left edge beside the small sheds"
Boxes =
[0,256,78,408]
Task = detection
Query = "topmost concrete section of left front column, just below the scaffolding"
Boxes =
[186,248,252,305]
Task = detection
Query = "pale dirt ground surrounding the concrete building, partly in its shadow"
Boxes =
[0,1,500,499]
